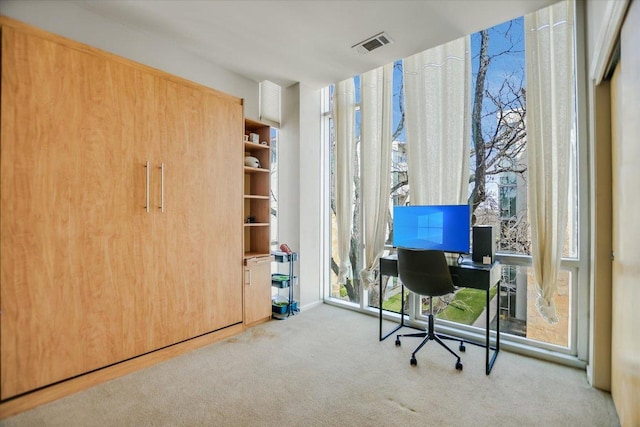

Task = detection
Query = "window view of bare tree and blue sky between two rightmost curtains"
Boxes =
[469,20,530,255]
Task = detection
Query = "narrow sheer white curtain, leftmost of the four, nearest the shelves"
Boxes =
[333,79,355,284]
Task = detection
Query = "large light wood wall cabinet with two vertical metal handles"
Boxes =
[0,18,243,400]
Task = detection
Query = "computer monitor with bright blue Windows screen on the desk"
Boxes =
[393,205,471,254]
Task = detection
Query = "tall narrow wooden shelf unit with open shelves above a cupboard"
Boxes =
[244,119,272,325]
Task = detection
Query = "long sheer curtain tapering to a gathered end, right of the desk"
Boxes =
[524,1,575,324]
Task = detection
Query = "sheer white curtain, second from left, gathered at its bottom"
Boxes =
[360,64,393,289]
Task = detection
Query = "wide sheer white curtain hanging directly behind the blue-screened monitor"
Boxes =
[403,37,471,205]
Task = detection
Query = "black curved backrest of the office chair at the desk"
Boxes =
[398,248,455,297]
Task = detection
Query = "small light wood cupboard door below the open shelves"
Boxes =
[244,256,272,326]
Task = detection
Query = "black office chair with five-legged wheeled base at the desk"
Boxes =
[396,248,465,370]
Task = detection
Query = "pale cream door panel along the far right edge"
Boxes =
[611,0,640,426]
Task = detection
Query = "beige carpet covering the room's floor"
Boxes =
[0,305,619,427]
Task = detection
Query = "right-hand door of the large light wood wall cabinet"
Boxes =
[154,77,243,342]
